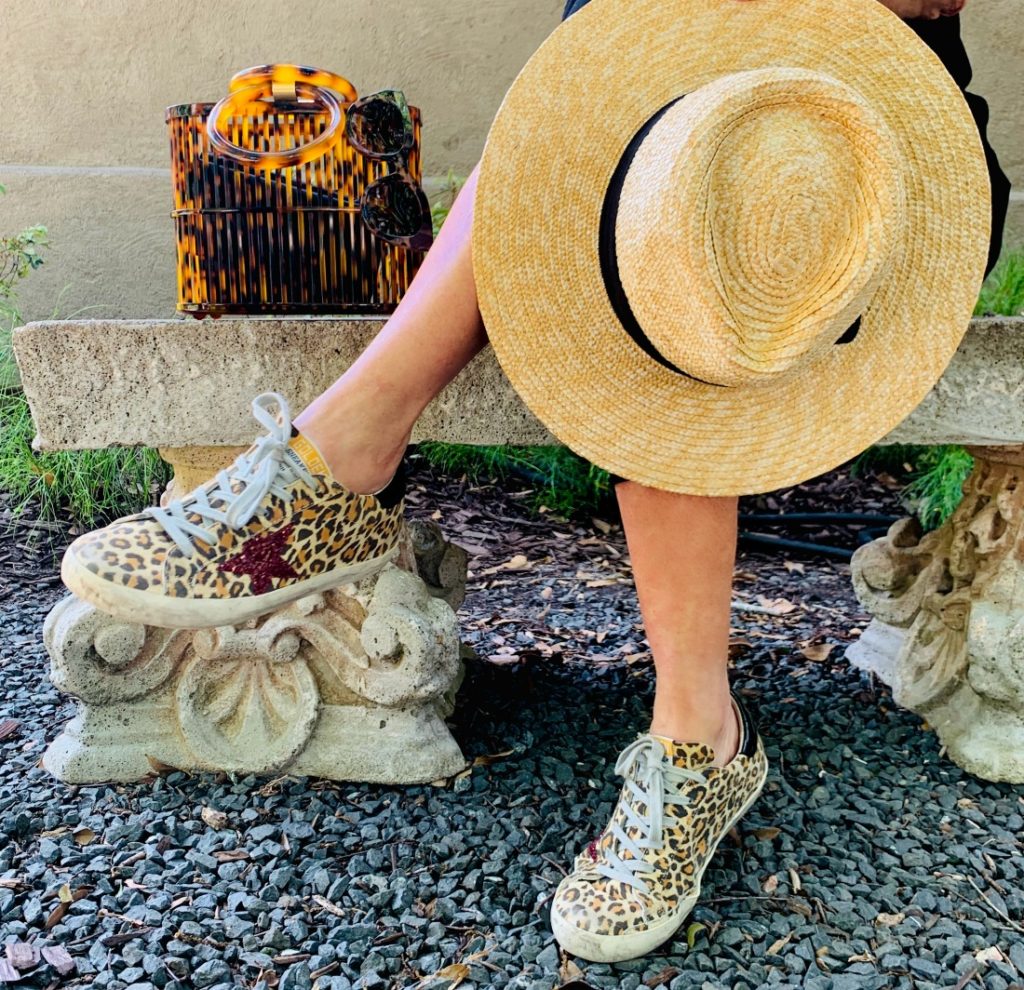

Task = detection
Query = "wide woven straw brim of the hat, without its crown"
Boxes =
[472,0,991,496]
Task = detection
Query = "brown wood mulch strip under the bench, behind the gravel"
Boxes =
[0,456,907,673]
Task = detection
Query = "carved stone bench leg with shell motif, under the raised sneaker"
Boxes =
[43,448,466,783]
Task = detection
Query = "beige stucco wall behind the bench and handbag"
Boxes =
[0,0,1024,320]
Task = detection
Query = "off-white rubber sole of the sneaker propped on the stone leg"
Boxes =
[60,545,399,629]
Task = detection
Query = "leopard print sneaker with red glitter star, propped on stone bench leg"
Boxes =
[60,392,406,629]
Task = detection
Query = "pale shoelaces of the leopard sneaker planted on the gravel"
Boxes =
[594,735,707,894]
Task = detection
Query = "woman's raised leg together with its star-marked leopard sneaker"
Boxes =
[61,163,486,629]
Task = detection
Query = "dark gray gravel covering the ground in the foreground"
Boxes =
[0,491,1024,990]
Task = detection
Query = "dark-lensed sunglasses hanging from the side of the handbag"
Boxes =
[345,89,433,251]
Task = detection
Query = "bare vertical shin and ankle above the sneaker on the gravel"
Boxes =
[615,481,739,766]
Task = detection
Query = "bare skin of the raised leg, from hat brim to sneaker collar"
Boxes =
[295,165,487,503]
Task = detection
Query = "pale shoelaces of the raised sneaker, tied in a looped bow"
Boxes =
[143,392,316,557]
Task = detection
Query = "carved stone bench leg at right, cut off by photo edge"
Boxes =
[847,446,1024,783]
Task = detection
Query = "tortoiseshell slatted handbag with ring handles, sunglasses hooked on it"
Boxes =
[165,63,432,318]
